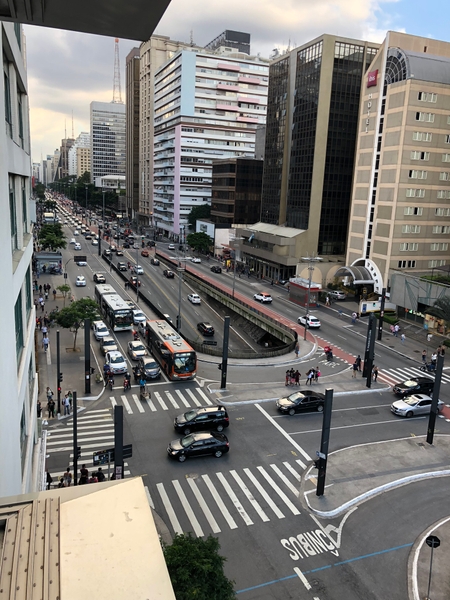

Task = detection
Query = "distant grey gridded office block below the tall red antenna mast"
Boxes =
[90,102,125,183]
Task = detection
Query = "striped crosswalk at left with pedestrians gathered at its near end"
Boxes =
[47,408,131,482]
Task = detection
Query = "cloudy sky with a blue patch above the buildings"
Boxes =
[25,0,450,162]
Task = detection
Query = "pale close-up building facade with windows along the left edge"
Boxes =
[0,22,38,497]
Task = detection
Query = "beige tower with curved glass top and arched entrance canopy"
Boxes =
[340,32,450,293]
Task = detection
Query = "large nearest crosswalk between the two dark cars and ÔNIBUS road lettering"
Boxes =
[148,460,305,537]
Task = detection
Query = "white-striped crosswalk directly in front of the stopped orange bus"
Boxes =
[109,387,214,415]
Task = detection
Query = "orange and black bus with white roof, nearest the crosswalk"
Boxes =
[142,320,197,381]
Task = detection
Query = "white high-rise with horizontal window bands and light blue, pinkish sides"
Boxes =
[153,49,269,237]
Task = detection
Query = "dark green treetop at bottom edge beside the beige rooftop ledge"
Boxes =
[163,533,236,600]
